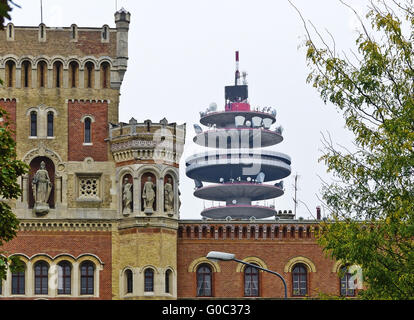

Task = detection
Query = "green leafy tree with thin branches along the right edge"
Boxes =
[298,0,414,299]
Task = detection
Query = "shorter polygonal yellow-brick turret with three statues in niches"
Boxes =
[109,118,185,299]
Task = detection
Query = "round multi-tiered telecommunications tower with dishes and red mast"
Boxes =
[186,51,291,219]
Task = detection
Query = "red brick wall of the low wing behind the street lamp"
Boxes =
[177,222,339,298]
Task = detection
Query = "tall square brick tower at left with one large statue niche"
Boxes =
[0,9,130,299]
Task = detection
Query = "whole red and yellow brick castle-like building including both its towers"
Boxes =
[0,9,353,299]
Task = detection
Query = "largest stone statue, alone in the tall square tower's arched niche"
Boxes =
[32,161,52,214]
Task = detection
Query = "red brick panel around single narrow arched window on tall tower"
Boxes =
[68,100,108,161]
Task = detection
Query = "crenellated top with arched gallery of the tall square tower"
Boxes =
[0,9,130,89]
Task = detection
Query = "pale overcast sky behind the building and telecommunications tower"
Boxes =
[8,0,367,219]
